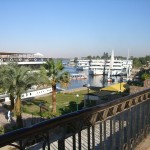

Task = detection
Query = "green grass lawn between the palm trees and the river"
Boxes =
[22,90,94,117]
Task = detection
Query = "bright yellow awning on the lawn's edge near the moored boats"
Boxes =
[100,82,129,92]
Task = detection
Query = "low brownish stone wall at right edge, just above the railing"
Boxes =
[130,79,150,94]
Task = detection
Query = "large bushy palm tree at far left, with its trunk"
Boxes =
[2,65,38,127]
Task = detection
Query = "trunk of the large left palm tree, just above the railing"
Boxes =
[15,97,23,128]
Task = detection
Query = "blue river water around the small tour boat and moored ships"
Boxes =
[58,66,120,89]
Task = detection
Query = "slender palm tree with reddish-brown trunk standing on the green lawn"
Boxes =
[44,59,70,113]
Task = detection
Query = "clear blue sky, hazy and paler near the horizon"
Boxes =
[0,0,150,58]
